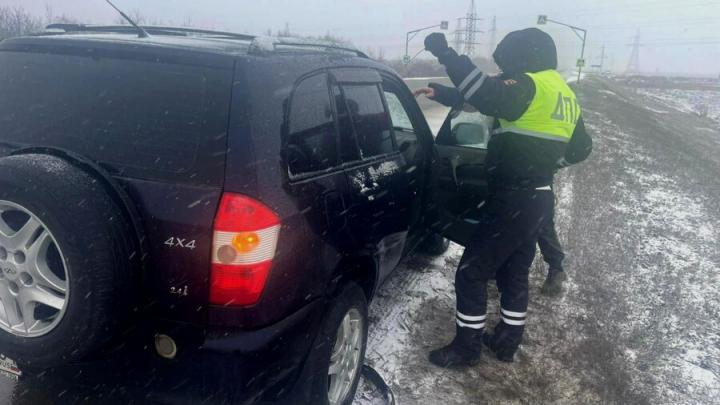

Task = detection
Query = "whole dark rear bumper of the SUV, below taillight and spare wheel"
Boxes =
[18,300,323,404]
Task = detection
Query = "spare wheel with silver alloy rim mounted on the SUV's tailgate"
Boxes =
[0,154,140,369]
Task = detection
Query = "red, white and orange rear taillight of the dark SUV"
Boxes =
[210,193,280,306]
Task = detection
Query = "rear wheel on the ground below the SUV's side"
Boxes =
[310,282,368,405]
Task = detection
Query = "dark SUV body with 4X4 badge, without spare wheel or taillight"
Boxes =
[0,26,450,403]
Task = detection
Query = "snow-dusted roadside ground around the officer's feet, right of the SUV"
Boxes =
[356,79,720,405]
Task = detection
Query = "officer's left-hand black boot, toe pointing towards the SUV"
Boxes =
[429,326,483,368]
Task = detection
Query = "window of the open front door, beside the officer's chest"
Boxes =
[438,106,492,149]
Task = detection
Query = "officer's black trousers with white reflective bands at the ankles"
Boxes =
[455,190,554,350]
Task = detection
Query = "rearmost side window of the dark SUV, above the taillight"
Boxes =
[286,73,338,175]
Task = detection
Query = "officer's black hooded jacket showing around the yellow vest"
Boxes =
[432,29,592,190]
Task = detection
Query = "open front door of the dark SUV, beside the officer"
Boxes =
[427,105,493,245]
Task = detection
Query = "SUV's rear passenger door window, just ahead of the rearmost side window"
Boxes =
[343,84,395,158]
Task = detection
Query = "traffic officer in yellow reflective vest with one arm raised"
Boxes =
[421,28,589,367]
